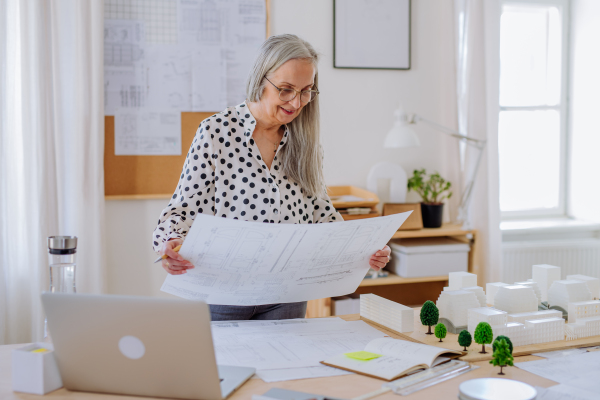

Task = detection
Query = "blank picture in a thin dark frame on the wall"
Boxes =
[333,0,410,69]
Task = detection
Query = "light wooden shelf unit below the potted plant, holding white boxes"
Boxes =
[306,224,477,318]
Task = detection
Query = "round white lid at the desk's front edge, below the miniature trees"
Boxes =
[458,378,537,400]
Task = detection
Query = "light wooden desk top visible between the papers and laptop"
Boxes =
[0,315,556,400]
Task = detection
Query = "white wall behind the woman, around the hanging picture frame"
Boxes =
[106,0,459,295]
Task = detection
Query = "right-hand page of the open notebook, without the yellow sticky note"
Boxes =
[365,338,461,367]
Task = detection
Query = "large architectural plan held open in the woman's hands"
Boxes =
[161,212,410,305]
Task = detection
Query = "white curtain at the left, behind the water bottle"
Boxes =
[0,0,105,344]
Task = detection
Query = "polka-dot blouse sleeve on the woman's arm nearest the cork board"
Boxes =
[152,121,215,253]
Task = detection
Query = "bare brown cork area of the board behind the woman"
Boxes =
[104,112,215,200]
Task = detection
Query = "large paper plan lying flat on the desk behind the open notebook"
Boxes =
[212,321,385,370]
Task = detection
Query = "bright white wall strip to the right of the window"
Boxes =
[570,0,600,222]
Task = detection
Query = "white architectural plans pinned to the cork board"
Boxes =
[104,0,267,155]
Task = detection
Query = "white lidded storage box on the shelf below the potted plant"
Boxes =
[387,238,470,278]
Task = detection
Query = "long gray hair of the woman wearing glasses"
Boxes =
[246,34,325,196]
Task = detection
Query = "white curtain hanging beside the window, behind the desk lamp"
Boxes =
[454,0,502,284]
